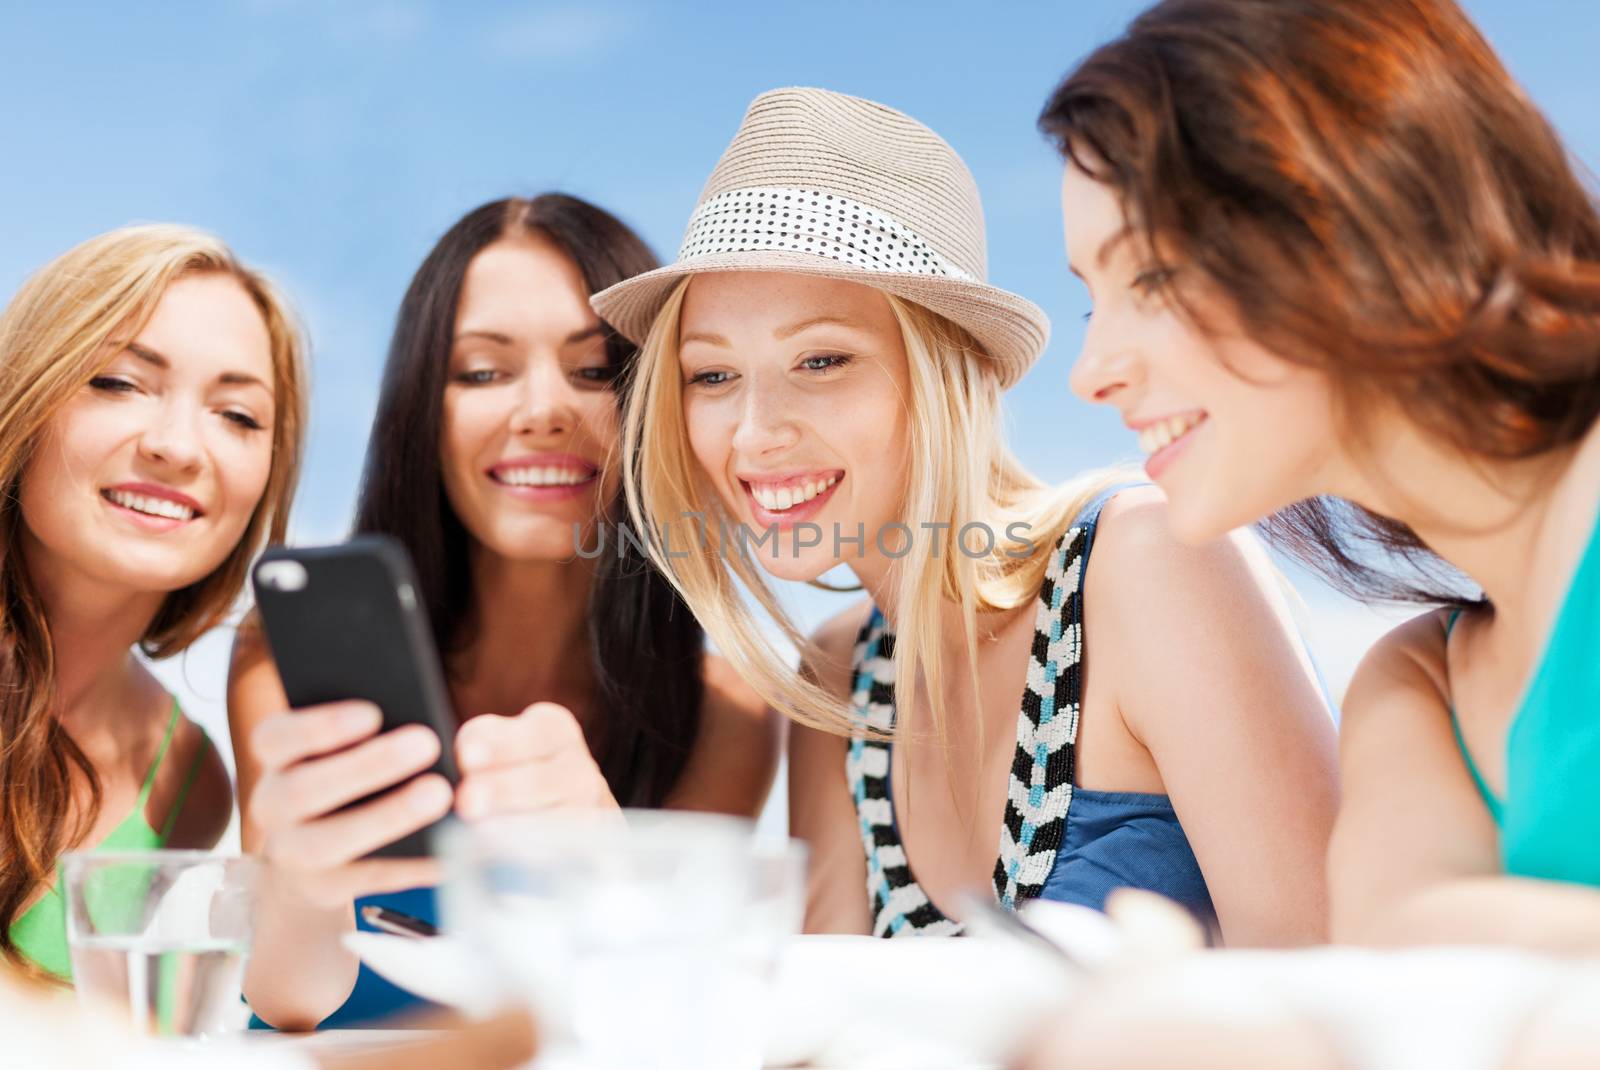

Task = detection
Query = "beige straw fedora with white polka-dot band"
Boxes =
[590,90,1050,387]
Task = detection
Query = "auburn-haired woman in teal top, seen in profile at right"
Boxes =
[1040,0,1600,950]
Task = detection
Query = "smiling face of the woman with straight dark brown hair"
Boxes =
[440,235,619,560]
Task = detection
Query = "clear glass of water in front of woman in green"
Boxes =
[62,851,258,1036]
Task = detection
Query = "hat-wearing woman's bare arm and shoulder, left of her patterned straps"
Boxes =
[789,605,872,932]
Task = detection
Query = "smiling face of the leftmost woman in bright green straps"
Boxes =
[21,273,274,595]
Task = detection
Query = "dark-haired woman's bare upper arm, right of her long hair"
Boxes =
[666,654,784,817]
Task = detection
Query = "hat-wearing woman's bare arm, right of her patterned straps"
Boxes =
[1085,491,1339,945]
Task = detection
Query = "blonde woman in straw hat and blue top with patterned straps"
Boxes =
[594,90,1336,944]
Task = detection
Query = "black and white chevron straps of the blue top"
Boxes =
[845,526,1086,936]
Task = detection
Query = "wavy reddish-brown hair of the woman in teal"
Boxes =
[1040,0,1600,601]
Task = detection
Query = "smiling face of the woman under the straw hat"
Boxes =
[678,272,910,581]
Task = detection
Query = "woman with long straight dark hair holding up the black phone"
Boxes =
[229,194,779,1028]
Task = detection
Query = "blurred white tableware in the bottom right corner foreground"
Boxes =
[1024,947,1600,1070]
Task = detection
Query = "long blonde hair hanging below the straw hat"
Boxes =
[622,280,1123,741]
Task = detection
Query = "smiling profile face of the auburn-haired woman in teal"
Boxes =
[1061,165,1342,542]
